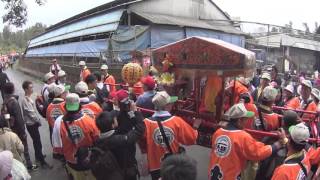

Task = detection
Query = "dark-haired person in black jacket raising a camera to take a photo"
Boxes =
[96,103,145,180]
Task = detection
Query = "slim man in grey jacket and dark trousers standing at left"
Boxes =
[21,81,52,168]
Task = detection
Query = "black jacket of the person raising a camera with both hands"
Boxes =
[96,112,145,172]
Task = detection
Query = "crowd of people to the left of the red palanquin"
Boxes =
[0,59,198,180]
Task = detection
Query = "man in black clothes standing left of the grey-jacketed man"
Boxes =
[3,82,38,170]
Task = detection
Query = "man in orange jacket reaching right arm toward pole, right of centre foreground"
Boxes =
[209,103,284,180]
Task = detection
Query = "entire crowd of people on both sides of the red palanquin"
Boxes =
[0,59,320,180]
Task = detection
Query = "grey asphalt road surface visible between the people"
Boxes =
[1,69,210,180]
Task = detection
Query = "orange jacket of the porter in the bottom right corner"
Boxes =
[272,148,320,180]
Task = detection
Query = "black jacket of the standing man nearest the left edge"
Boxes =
[4,95,26,139]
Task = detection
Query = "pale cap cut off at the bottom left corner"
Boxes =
[0,151,13,179]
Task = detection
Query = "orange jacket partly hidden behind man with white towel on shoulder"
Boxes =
[46,98,66,128]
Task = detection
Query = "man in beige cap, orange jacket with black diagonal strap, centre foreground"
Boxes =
[143,91,200,180]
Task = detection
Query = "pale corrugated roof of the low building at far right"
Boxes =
[255,34,320,51]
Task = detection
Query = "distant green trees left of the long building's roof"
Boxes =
[0,23,46,54]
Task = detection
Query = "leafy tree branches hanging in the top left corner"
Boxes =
[1,0,44,27]
